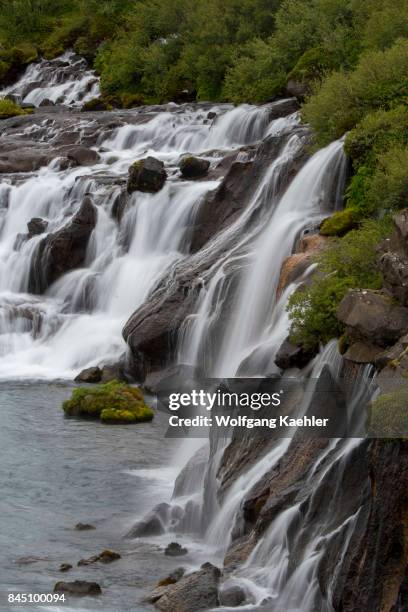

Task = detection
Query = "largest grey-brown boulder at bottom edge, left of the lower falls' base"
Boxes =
[154,563,221,612]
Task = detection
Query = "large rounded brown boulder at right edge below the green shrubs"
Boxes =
[337,290,408,348]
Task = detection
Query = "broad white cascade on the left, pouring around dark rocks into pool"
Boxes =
[0,100,290,378]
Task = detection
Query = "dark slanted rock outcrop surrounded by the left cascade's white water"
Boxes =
[29,197,97,294]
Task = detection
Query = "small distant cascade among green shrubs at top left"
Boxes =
[0,51,100,106]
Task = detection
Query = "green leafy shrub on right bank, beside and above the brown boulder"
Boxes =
[289,218,392,347]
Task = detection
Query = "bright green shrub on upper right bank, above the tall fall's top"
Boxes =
[303,40,408,145]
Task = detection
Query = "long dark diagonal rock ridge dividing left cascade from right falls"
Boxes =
[123,130,308,380]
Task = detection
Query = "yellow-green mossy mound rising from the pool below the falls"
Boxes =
[62,380,154,424]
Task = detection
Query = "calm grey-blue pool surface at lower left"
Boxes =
[0,382,180,612]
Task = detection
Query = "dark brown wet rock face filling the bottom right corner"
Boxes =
[327,440,408,612]
